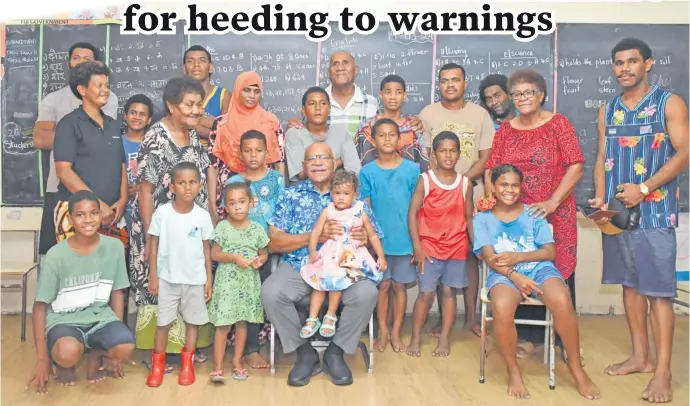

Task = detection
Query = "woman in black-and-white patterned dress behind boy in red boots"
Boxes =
[129,77,213,362]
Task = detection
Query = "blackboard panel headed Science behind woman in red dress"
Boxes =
[434,35,554,111]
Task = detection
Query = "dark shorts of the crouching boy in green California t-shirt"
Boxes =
[46,320,134,358]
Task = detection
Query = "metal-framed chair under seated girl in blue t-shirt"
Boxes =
[479,247,556,390]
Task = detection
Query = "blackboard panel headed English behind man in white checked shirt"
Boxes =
[319,24,434,115]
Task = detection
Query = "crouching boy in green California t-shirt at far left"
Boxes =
[27,190,134,393]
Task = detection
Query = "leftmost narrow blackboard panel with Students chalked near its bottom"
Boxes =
[2,25,43,204]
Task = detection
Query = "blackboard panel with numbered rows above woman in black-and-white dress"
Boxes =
[107,21,186,123]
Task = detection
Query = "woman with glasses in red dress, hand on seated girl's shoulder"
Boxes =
[485,69,585,358]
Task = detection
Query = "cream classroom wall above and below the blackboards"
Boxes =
[0,0,690,314]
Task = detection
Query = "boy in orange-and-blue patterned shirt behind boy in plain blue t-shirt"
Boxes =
[355,75,429,172]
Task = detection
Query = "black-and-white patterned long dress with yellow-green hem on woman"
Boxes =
[129,121,213,354]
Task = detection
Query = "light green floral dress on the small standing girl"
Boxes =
[208,220,268,327]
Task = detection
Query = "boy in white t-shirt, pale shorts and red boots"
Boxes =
[146,162,213,387]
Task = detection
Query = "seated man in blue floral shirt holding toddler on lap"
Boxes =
[261,142,383,386]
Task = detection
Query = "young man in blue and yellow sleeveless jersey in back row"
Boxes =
[182,45,231,147]
